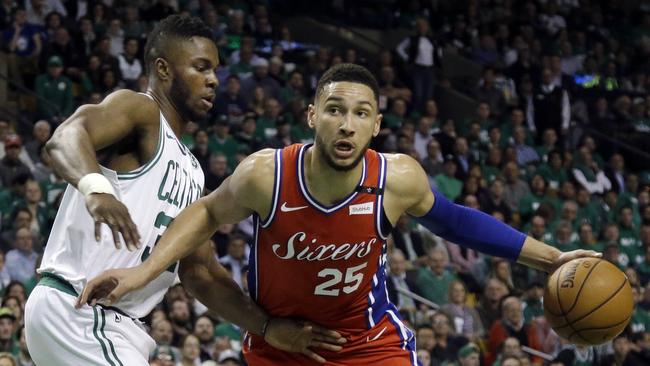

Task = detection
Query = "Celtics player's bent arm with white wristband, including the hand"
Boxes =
[45,90,158,248]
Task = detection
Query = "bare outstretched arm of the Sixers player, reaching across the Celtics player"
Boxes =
[78,150,275,305]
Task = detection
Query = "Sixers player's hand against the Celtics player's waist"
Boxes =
[75,267,146,309]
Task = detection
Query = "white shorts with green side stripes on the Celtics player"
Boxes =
[25,280,156,366]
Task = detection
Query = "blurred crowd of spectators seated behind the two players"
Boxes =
[0,0,650,366]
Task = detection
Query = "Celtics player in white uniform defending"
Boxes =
[25,16,342,366]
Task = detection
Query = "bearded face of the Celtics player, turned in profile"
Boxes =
[169,37,219,121]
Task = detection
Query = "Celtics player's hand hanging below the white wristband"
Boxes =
[86,193,140,251]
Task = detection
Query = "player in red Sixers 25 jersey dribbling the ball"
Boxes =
[78,64,598,366]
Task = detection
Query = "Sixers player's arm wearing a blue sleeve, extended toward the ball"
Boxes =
[386,155,599,272]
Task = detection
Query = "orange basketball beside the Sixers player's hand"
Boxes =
[544,258,634,345]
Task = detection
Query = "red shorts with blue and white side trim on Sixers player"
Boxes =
[243,314,420,366]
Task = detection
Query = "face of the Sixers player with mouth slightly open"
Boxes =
[308,81,382,171]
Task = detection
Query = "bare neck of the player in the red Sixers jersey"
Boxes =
[304,148,363,205]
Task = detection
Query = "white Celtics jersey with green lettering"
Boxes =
[38,103,204,318]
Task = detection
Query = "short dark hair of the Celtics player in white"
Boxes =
[144,14,212,73]
